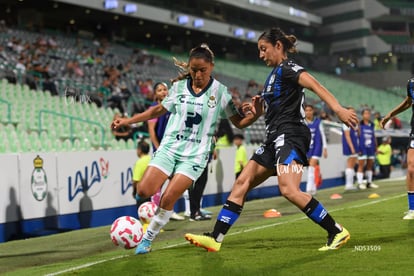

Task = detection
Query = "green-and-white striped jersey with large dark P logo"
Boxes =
[160,78,237,164]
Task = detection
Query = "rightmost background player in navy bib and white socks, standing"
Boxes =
[357,109,378,190]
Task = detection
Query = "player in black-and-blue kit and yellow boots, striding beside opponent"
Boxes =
[185,28,358,251]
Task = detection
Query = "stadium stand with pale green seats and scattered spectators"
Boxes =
[0,24,409,152]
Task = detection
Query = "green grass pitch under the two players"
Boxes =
[0,180,414,276]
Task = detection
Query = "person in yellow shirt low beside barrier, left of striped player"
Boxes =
[132,140,151,207]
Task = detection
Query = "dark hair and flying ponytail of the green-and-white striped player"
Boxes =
[171,43,214,83]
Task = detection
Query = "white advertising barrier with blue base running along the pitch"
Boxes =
[0,145,345,242]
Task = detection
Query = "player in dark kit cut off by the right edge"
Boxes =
[380,78,414,220]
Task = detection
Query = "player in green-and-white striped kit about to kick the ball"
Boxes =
[111,44,263,254]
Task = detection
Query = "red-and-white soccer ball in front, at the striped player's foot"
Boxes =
[110,216,143,249]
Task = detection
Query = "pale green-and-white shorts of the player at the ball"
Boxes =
[149,150,208,181]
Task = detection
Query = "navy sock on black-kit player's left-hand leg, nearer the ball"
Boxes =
[212,200,243,242]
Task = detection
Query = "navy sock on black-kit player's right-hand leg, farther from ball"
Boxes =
[302,197,342,234]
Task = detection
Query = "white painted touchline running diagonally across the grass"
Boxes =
[46,193,406,276]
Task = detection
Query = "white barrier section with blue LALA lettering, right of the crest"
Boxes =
[57,151,137,214]
